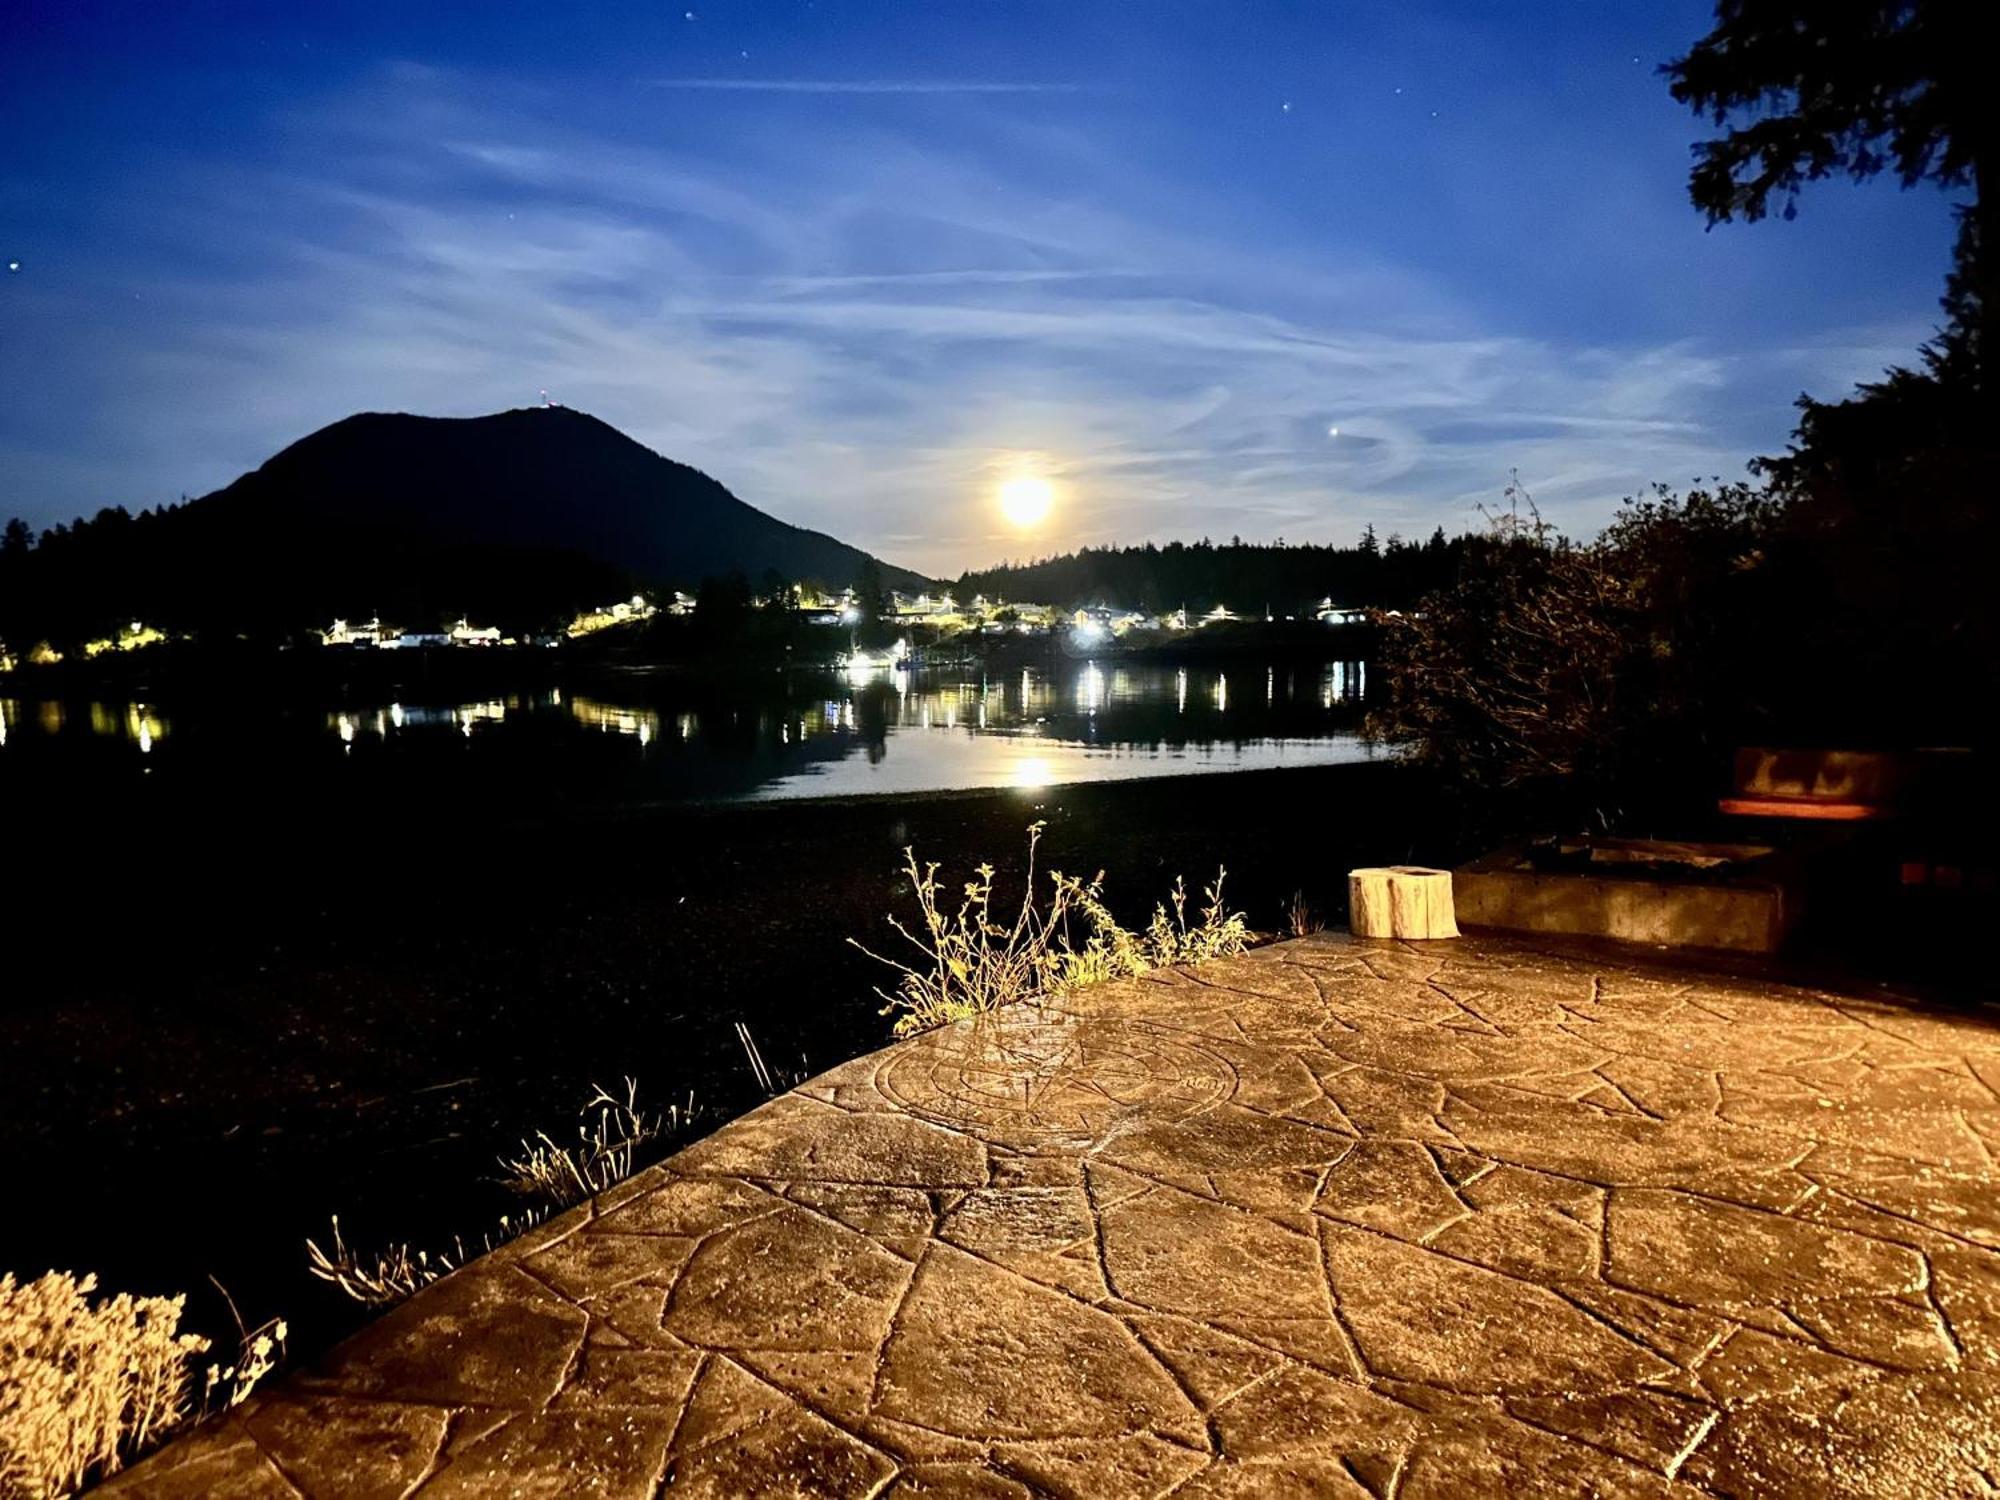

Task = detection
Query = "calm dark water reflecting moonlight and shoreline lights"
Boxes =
[0,662,1368,804]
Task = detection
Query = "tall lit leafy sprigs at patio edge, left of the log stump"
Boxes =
[848,822,1250,1036]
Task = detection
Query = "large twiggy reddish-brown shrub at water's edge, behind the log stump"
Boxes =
[1366,486,1772,830]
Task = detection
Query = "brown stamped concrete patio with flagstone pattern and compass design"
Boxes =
[110,936,2000,1500]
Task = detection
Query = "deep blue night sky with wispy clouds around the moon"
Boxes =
[0,0,1950,572]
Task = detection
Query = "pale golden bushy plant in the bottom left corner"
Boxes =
[0,1270,286,1500]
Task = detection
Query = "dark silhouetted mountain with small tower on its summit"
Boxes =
[12,406,926,636]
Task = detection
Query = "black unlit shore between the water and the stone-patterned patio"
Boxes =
[0,766,1464,1348]
